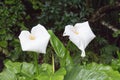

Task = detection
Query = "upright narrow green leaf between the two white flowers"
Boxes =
[48,30,73,67]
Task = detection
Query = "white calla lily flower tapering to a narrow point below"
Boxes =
[63,22,95,57]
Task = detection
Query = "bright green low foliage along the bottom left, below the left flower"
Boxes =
[0,60,66,80]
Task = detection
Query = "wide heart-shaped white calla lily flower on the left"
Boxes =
[19,24,50,53]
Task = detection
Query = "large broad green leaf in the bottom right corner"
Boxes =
[65,63,120,80]
